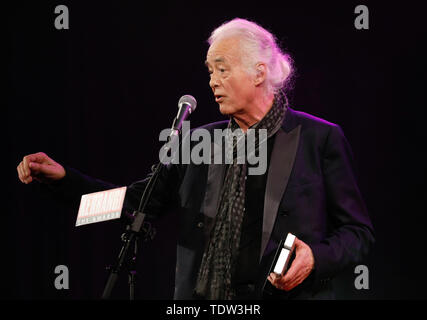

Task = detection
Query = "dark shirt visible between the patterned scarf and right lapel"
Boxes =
[233,135,275,298]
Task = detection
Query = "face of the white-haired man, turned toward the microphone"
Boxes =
[206,38,255,115]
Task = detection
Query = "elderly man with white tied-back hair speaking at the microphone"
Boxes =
[18,19,374,299]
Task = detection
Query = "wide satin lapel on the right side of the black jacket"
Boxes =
[260,125,301,260]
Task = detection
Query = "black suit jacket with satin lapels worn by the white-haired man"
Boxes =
[53,108,374,299]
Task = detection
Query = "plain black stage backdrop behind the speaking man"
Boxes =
[4,1,427,299]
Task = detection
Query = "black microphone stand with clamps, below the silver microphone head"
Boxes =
[102,162,165,300]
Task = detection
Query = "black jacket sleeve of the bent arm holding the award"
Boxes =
[310,126,374,280]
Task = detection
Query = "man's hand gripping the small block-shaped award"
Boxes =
[268,238,314,291]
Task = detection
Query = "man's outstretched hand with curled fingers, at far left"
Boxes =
[16,152,65,184]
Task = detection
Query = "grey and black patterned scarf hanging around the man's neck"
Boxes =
[195,93,287,300]
